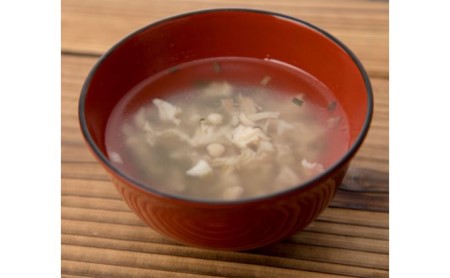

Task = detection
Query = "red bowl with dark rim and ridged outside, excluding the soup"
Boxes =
[79,9,373,250]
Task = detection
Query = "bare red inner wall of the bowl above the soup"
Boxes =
[80,10,372,200]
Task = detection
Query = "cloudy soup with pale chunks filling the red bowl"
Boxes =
[105,57,349,200]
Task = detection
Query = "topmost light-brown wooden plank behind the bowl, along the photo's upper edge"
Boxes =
[62,0,388,77]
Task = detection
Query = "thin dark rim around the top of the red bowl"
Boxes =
[78,8,374,206]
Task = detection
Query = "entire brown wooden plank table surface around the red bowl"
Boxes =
[61,0,389,277]
